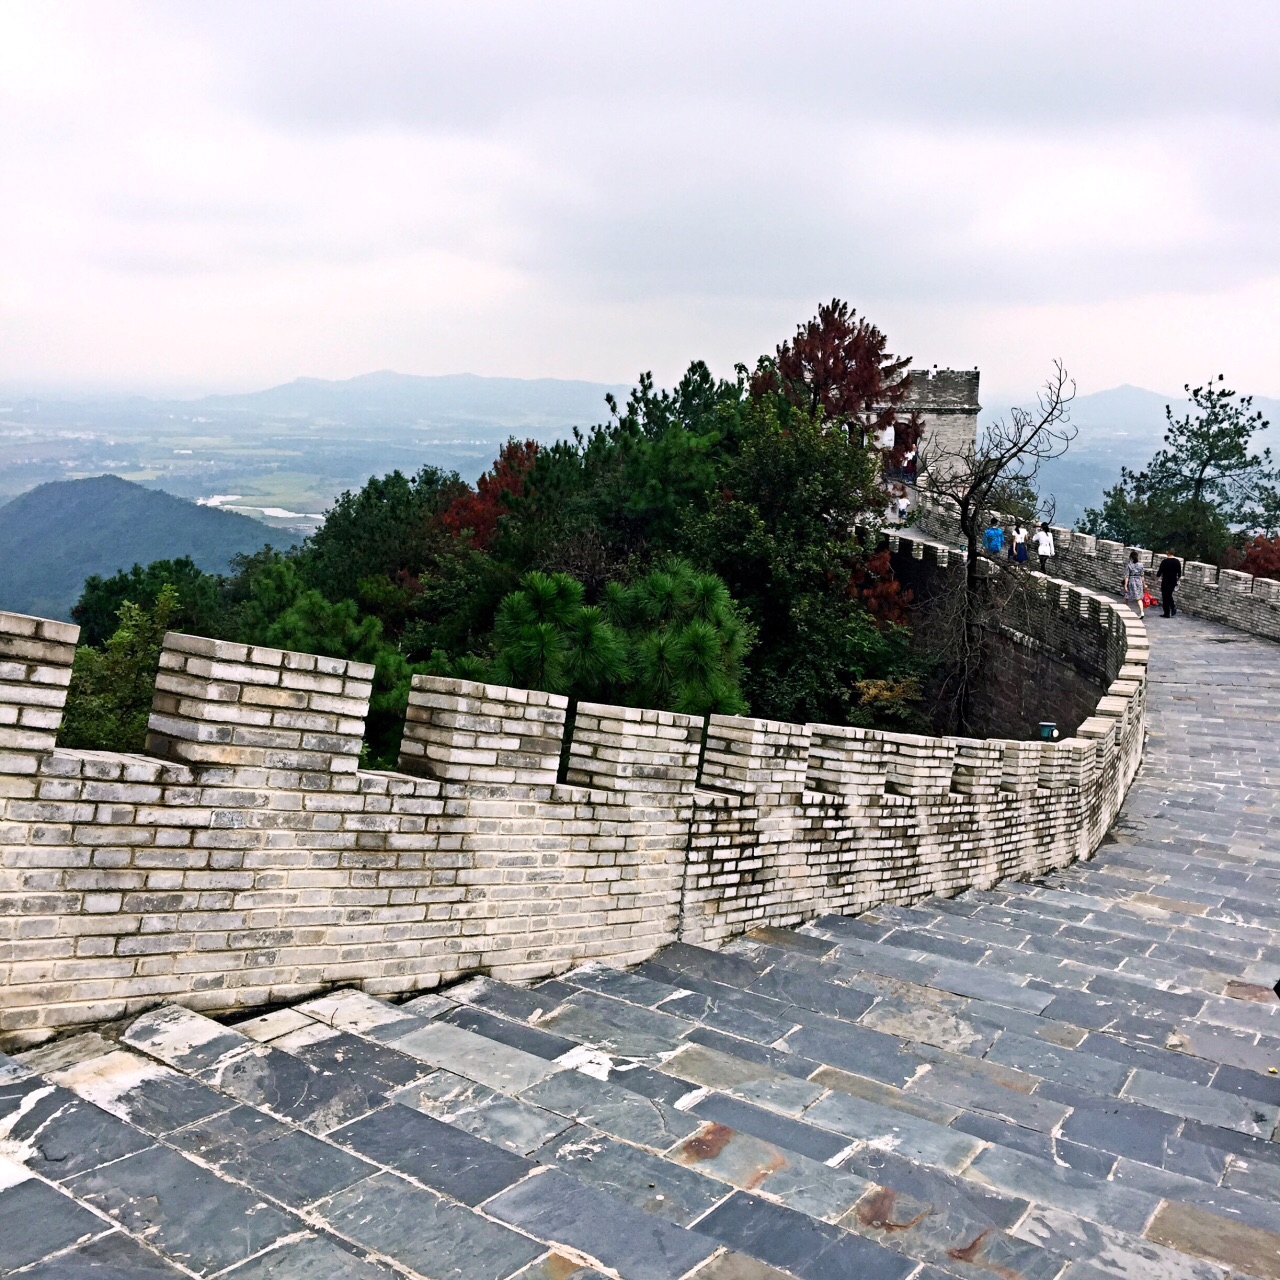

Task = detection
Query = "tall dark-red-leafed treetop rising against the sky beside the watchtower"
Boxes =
[751,298,911,452]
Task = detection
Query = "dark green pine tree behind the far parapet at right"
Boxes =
[1080,374,1280,563]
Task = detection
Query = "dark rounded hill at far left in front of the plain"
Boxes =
[0,476,297,618]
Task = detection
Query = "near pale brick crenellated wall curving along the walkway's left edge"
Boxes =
[0,539,1147,1047]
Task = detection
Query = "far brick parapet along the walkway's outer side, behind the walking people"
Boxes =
[914,490,1280,640]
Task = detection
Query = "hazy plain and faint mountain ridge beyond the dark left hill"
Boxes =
[0,372,628,532]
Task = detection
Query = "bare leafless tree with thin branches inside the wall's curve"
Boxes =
[916,360,1076,733]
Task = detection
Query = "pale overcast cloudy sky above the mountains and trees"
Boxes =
[0,0,1280,397]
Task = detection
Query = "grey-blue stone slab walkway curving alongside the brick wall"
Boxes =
[0,618,1280,1280]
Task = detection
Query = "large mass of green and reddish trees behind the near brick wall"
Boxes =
[67,302,919,763]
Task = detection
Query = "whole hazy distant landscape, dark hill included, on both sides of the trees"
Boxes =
[0,372,1280,617]
